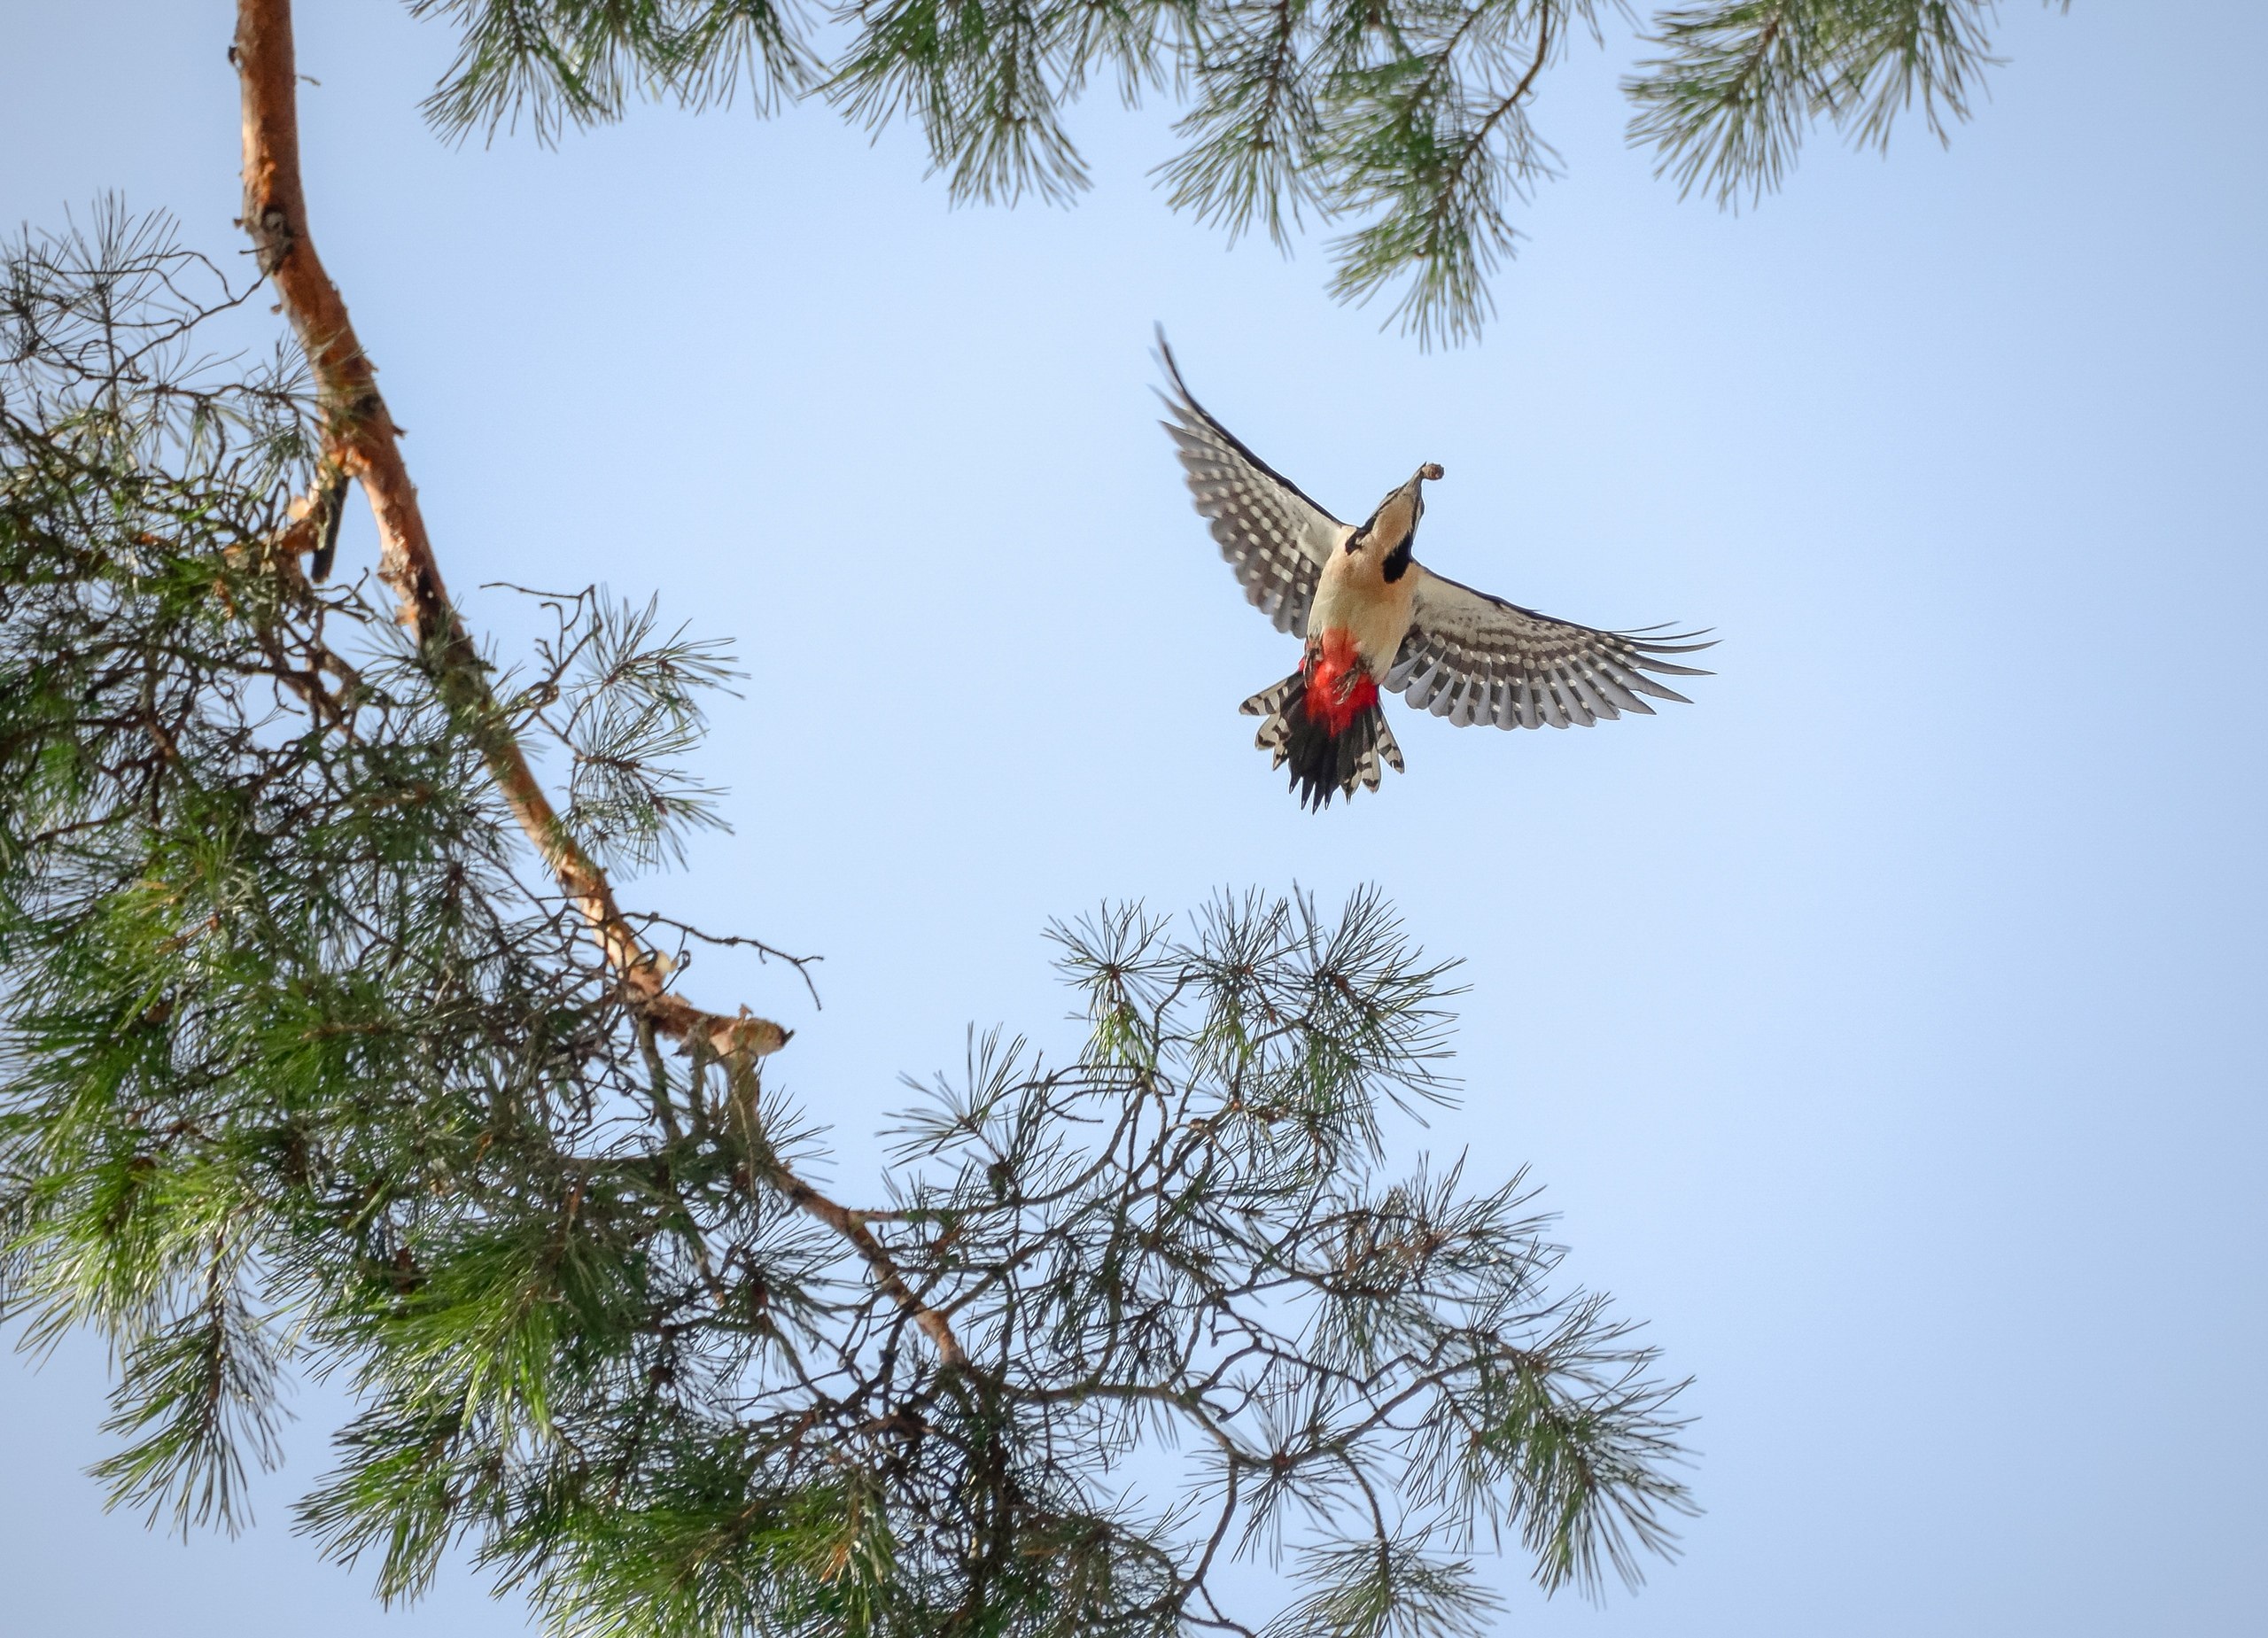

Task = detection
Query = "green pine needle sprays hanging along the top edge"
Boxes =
[410,0,2069,343]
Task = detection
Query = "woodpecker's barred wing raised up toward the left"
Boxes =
[1157,333,1348,633]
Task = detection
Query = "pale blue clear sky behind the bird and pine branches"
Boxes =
[0,0,2268,1638]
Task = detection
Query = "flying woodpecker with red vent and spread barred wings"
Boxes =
[1157,331,1714,810]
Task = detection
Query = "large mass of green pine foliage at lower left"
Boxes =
[0,213,1685,1638]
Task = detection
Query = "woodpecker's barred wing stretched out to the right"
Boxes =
[1386,565,1714,728]
